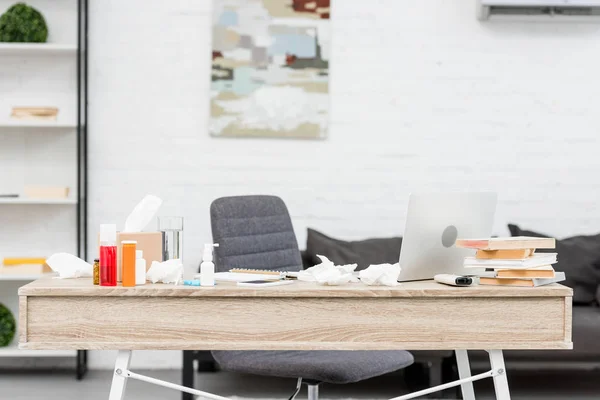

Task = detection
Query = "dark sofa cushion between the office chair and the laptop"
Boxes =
[306,228,402,270]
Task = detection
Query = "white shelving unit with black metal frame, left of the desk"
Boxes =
[0,0,87,376]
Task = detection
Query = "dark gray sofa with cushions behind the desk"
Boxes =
[303,224,600,394]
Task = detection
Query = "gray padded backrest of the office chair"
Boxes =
[210,196,302,271]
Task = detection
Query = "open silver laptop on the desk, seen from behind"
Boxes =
[398,192,498,282]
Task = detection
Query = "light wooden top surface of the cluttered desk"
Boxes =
[19,278,573,298]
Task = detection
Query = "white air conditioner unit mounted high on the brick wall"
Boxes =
[477,0,600,20]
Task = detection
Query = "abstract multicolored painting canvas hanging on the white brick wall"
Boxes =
[209,0,331,138]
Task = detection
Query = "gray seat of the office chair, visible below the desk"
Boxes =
[212,350,413,384]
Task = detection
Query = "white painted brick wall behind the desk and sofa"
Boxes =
[89,0,600,367]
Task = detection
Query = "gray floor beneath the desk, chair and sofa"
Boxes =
[0,370,600,400]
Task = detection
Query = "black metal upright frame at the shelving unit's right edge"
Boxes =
[76,0,88,380]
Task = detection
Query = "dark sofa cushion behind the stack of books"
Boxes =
[508,224,600,304]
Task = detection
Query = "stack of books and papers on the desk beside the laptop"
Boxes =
[456,236,565,286]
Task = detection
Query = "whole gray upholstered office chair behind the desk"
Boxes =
[210,196,413,400]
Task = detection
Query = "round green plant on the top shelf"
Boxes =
[0,3,48,43]
